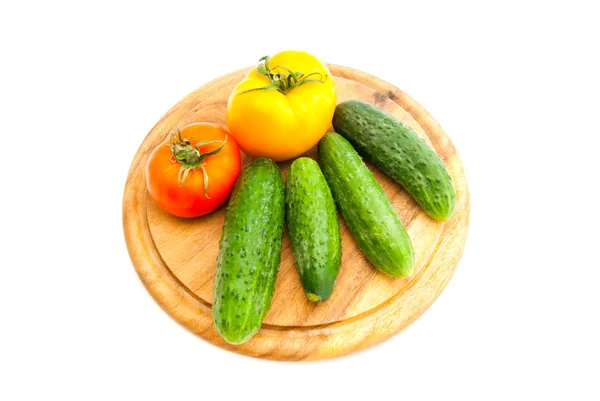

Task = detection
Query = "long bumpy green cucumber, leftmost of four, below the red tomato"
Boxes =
[212,158,285,344]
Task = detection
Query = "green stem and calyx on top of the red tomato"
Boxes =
[169,131,228,199]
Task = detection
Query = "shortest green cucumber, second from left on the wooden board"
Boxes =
[285,157,342,302]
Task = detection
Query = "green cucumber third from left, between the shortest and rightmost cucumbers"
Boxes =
[318,133,414,277]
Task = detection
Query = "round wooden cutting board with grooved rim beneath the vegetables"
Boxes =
[123,65,469,361]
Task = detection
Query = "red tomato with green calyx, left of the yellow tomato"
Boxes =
[146,123,241,217]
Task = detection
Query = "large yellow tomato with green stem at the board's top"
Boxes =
[227,50,336,161]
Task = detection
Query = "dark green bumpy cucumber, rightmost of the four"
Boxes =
[333,100,456,221]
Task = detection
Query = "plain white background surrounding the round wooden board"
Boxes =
[0,0,600,400]
